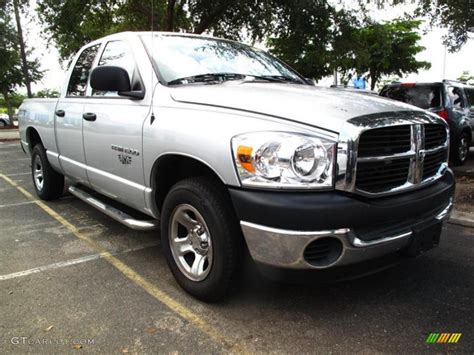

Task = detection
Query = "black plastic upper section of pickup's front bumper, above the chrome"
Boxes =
[229,170,455,235]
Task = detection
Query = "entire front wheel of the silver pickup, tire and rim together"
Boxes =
[161,177,243,302]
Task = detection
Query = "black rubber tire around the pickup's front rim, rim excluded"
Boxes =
[161,181,239,302]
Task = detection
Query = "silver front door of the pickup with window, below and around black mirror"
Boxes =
[83,40,150,210]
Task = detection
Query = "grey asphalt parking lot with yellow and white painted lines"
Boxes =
[0,142,474,353]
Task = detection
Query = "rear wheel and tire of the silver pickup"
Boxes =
[31,143,64,201]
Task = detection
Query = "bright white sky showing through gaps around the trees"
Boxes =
[23,0,474,92]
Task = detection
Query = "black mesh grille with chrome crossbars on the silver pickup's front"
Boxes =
[355,124,448,195]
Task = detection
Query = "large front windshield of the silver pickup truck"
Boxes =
[142,34,303,83]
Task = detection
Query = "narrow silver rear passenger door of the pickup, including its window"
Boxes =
[55,44,100,185]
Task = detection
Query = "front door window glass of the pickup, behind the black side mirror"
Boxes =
[92,41,141,97]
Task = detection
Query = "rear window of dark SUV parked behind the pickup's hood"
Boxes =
[380,84,442,110]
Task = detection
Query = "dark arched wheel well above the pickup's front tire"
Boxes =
[151,154,224,211]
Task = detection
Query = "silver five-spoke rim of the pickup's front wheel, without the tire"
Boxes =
[169,204,212,281]
